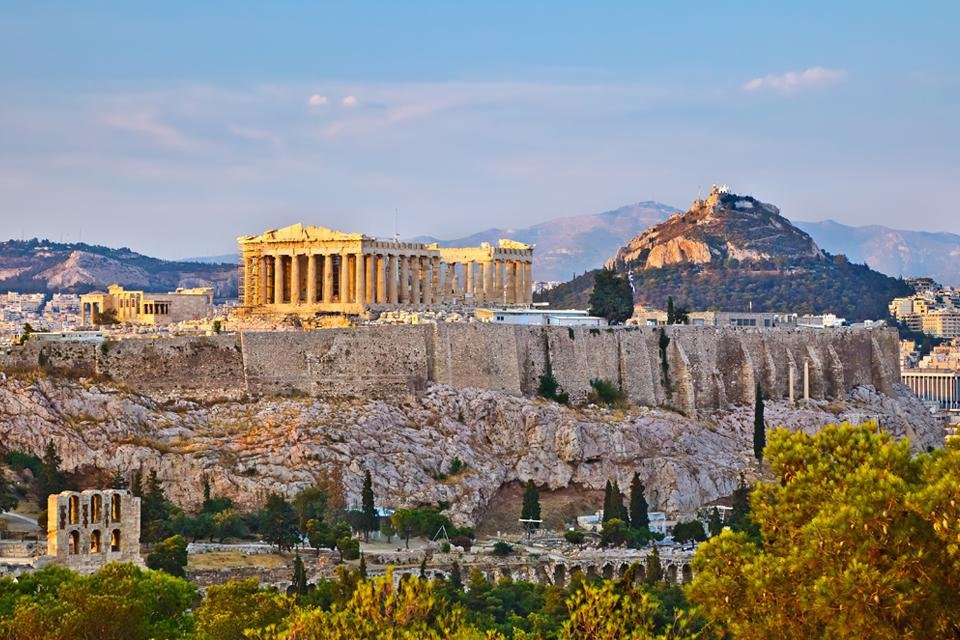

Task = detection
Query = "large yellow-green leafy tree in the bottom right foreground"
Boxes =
[689,424,960,640]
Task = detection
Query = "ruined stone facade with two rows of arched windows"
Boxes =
[47,489,143,573]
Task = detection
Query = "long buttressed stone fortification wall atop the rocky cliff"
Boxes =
[0,323,900,415]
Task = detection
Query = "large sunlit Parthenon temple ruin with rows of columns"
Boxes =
[237,224,533,315]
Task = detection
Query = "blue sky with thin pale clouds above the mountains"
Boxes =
[0,0,960,258]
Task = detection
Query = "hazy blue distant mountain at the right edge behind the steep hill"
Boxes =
[796,220,960,286]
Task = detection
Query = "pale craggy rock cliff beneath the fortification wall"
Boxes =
[0,378,943,523]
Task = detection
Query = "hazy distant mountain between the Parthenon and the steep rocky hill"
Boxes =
[412,201,677,281]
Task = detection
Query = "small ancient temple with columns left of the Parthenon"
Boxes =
[80,284,213,327]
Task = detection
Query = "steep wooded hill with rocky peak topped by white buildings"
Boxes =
[538,188,911,320]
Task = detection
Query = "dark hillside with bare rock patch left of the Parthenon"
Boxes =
[0,238,238,298]
